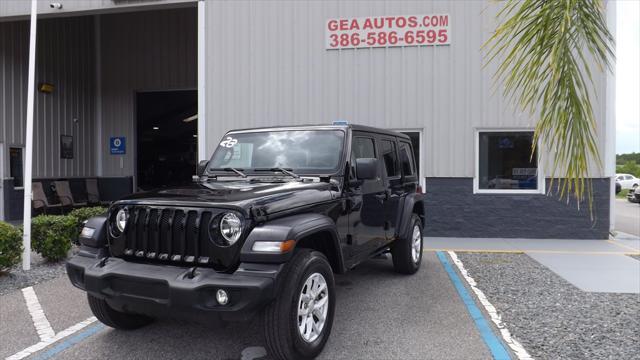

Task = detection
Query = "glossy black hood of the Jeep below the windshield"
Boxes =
[119,180,335,214]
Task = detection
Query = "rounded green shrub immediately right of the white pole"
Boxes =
[31,215,78,261]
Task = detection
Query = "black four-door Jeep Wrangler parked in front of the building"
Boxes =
[67,125,425,359]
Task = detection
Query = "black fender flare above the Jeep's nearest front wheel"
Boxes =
[240,214,344,273]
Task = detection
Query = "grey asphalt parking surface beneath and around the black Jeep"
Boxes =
[0,252,504,359]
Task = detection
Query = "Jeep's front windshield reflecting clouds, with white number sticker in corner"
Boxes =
[207,130,344,174]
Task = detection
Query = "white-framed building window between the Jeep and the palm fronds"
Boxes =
[475,131,544,193]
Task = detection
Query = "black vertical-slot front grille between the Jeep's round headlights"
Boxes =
[109,206,235,266]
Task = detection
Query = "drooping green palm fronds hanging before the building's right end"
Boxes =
[484,0,613,209]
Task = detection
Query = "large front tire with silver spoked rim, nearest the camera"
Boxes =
[263,249,336,360]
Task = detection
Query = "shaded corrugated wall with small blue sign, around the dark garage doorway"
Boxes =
[100,7,197,176]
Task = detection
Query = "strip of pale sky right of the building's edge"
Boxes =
[616,0,640,154]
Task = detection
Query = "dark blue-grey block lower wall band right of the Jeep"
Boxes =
[425,178,610,239]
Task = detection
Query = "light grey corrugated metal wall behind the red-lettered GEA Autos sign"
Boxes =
[206,0,606,177]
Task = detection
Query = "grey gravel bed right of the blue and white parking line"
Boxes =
[458,253,640,359]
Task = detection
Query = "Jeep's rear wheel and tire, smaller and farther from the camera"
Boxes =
[391,214,423,275]
